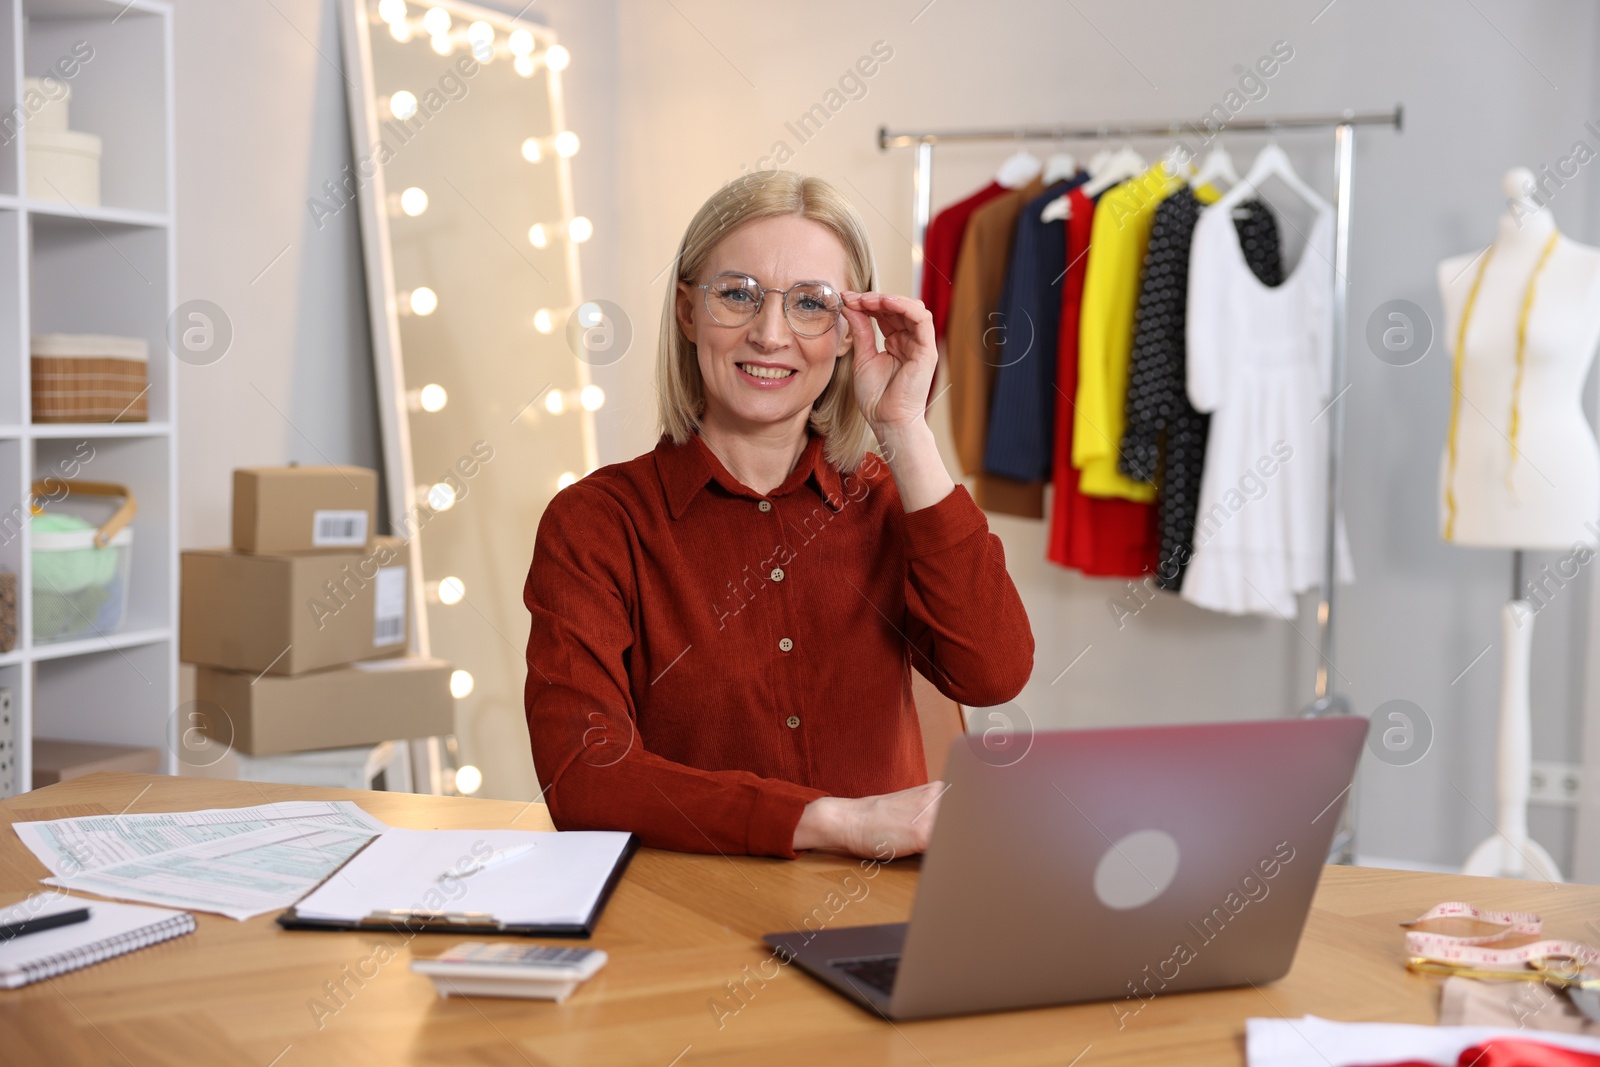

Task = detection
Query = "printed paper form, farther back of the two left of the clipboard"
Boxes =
[13,800,387,878]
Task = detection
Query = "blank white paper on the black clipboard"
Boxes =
[294,830,629,925]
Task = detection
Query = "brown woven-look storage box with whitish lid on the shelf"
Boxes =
[32,333,150,422]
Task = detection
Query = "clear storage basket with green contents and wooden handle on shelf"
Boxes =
[29,480,138,645]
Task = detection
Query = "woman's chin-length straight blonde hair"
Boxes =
[656,171,878,472]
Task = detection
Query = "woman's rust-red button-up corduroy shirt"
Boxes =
[523,437,1034,857]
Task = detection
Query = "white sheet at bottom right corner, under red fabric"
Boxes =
[1245,1016,1600,1067]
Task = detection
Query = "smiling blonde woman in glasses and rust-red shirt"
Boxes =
[525,173,1034,857]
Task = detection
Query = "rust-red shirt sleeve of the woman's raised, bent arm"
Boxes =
[902,485,1034,707]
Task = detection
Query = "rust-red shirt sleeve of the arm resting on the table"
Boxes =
[523,483,827,859]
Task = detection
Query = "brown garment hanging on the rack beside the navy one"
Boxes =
[946,178,1045,518]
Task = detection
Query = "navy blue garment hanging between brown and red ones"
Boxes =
[984,171,1088,482]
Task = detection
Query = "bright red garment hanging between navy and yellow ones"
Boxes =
[1045,189,1160,577]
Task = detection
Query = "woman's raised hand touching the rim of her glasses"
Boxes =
[843,291,939,430]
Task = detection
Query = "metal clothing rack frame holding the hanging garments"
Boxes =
[878,104,1405,864]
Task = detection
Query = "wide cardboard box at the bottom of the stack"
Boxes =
[195,656,456,755]
